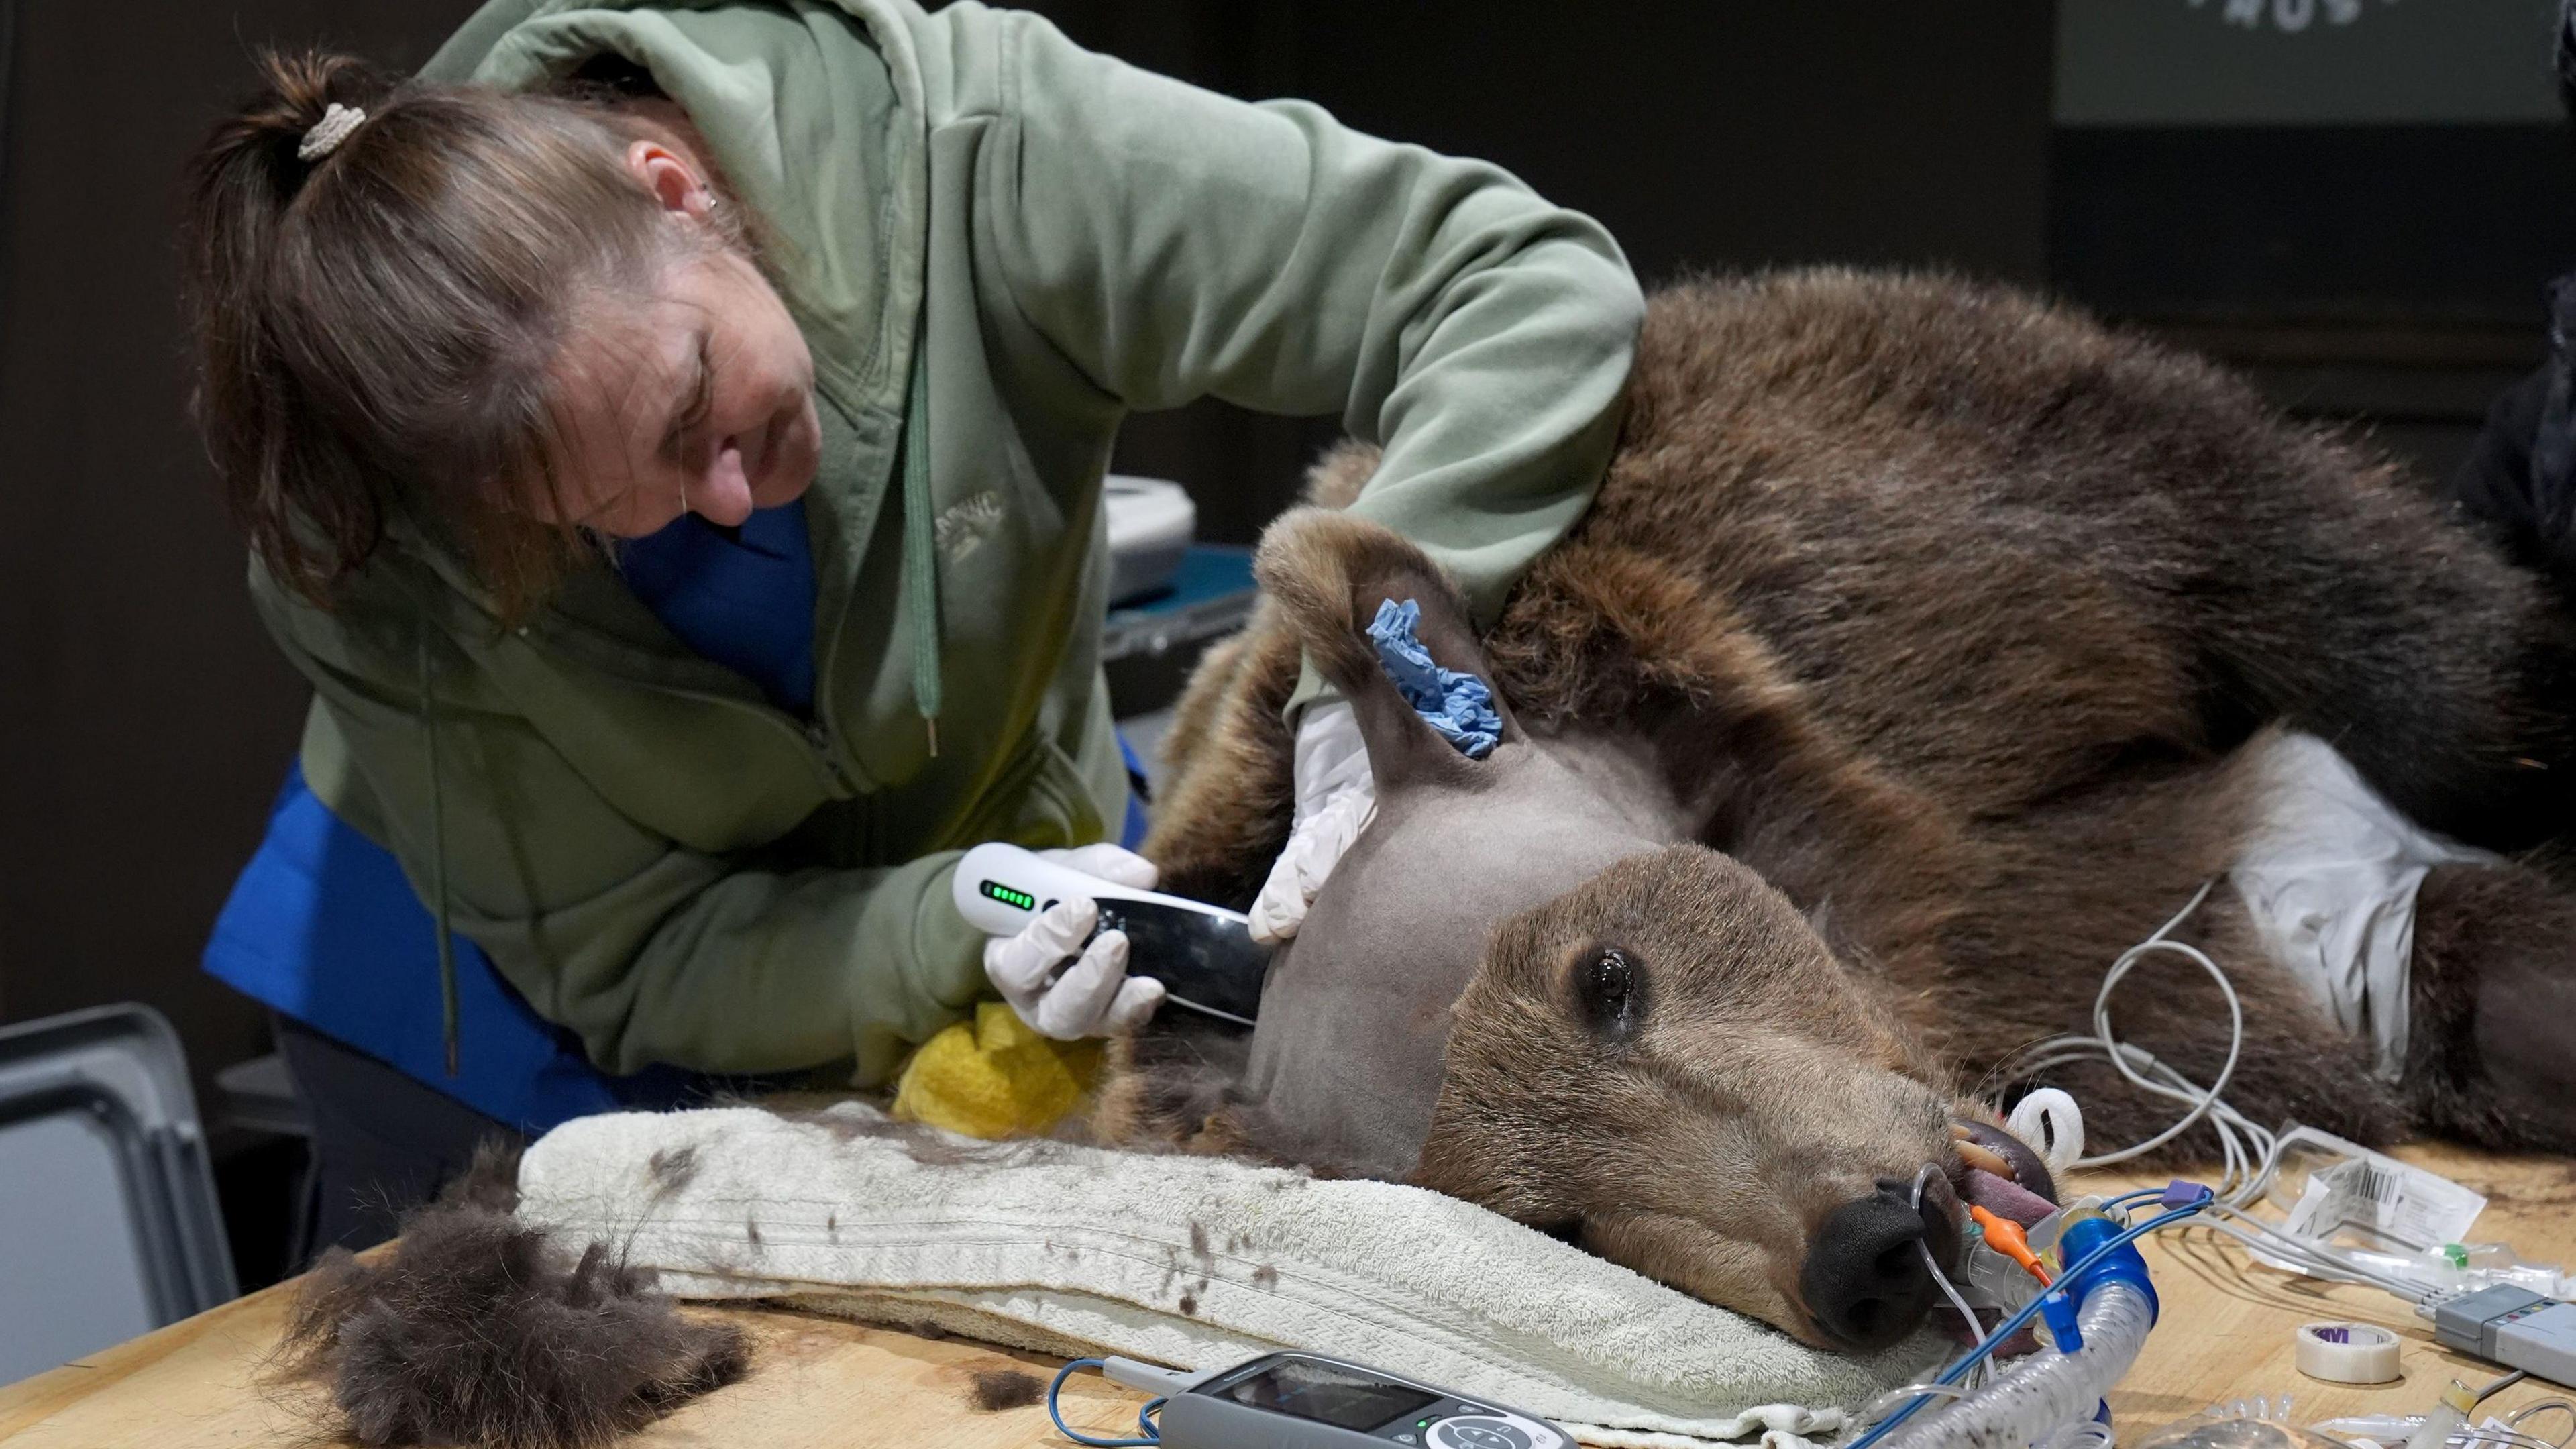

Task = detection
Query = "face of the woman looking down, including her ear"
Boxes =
[528,142,822,539]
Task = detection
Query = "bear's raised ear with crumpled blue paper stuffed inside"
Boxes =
[1252,508,1522,784]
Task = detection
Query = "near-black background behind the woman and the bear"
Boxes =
[0,0,2576,1271]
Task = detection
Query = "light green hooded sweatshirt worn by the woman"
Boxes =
[250,0,1644,1085]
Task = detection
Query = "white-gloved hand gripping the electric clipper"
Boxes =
[984,846,1162,1042]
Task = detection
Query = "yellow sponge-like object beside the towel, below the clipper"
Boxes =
[894,1000,1100,1137]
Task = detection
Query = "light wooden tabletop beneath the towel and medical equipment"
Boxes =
[0,1147,2576,1449]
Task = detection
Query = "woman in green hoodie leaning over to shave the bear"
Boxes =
[191,0,1641,1238]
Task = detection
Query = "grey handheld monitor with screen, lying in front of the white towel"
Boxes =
[1046,1354,1574,1449]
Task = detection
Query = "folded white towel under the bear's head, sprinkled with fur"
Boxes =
[518,1104,1942,1449]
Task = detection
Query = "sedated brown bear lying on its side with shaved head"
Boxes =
[1095,271,2576,1348]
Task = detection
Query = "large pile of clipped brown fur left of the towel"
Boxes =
[281,1189,749,1449]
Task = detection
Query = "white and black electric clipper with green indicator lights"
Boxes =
[951,841,1270,1026]
